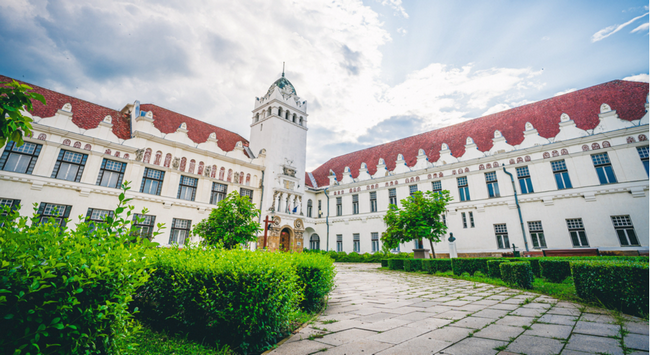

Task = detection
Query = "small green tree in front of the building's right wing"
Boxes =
[381,190,451,258]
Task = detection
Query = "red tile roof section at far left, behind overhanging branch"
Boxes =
[0,75,131,139]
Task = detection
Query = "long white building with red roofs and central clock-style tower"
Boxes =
[0,75,648,255]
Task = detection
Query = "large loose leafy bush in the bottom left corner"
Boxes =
[0,183,157,355]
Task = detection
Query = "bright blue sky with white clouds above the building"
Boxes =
[0,0,650,171]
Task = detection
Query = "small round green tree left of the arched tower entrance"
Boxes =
[192,191,262,249]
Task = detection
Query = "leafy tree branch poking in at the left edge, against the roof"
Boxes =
[0,80,45,147]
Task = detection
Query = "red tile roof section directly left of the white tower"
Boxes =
[140,104,248,152]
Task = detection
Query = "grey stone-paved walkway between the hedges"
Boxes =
[272,264,648,355]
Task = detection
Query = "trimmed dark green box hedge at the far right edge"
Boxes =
[571,260,650,316]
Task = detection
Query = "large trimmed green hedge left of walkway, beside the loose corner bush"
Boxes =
[136,247,302,353]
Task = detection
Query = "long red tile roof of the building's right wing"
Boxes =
[305,80,648,187]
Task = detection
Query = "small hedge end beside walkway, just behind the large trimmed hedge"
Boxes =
[293,254,336,312]
